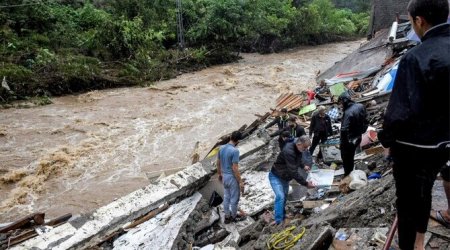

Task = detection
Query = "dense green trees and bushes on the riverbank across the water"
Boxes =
[0,0,369,102]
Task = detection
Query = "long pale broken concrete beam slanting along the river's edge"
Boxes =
[13,162,214,249]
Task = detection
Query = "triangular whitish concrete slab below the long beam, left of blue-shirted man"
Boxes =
[114,193,202,250]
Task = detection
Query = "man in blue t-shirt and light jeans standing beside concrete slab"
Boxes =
[217,131,244,224]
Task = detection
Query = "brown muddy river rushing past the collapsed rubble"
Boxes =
[0,41,362,223]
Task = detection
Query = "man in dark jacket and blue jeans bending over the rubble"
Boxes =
[269,135,315,225]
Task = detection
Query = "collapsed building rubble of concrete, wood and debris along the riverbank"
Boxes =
[0,16,450,249]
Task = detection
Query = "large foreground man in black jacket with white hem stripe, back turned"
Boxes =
[378,0,450,250]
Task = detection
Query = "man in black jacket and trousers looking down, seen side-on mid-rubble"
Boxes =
[338,92,368,176]
